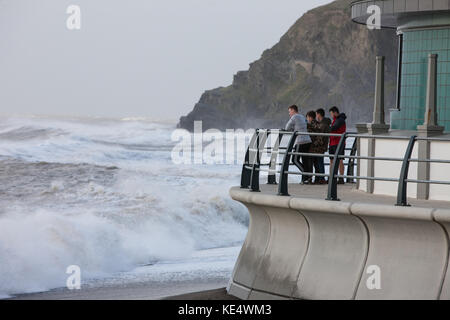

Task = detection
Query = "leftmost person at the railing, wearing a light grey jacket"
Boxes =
[285,105,312,184]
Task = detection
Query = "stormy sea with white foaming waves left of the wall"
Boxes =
[0,116,249,298]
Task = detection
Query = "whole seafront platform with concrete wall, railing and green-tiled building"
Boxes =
[228,0,450,300]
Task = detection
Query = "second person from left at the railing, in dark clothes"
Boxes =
[306,111,328,184]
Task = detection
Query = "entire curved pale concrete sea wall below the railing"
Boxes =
[229,189,450,300]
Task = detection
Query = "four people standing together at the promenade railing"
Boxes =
[285,105,347,184]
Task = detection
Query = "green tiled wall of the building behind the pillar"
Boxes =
[391,29,450,131]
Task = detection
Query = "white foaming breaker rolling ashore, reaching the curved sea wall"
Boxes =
[0,186,248,295]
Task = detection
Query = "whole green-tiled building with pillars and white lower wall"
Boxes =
[351,0,450,201]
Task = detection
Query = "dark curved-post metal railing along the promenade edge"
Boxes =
[241,129,450,206]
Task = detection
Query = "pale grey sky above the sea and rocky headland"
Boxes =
[0,0,331,120]
